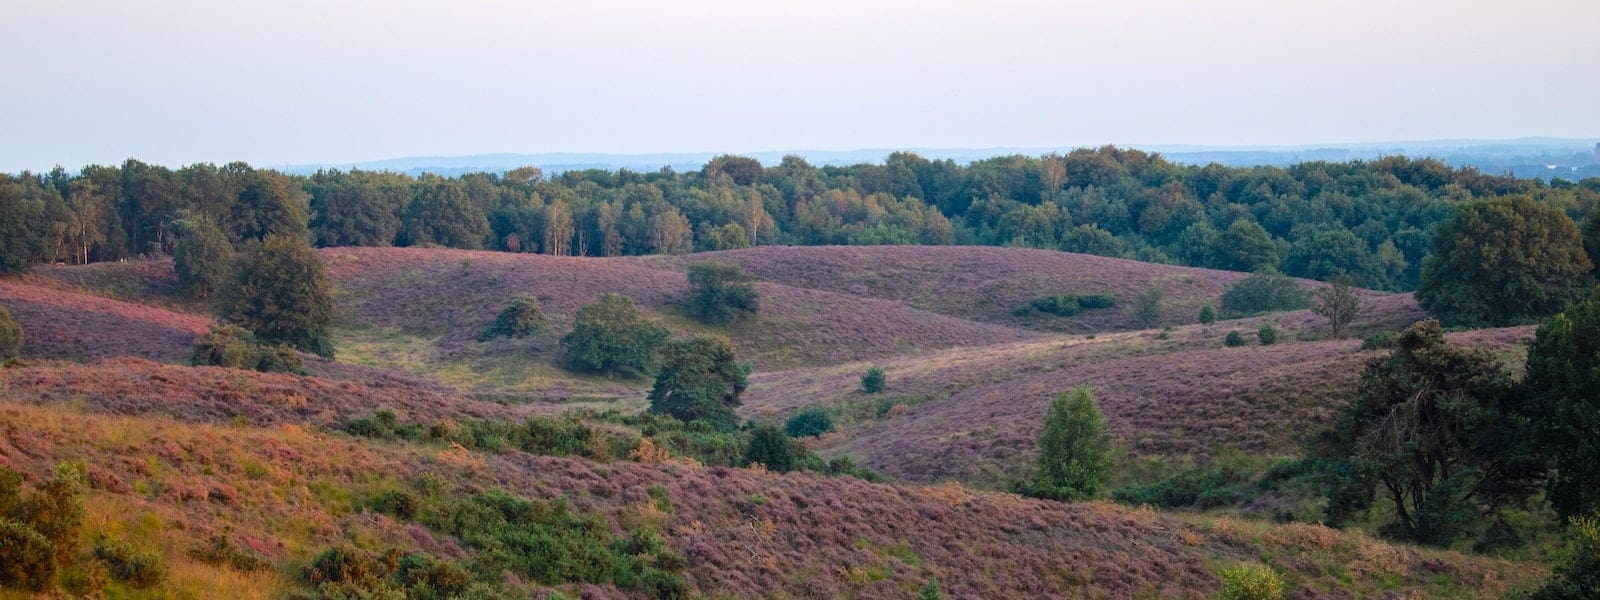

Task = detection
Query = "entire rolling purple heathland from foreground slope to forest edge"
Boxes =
[0,246,1544,598]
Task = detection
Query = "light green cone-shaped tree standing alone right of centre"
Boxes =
[1022,386,1112,501]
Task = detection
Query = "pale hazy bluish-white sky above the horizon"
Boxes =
[0,0,1600,171]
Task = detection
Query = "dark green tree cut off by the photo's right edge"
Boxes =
[1523,290,1600,517]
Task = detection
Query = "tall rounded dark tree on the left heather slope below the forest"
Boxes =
[222,235,333,358]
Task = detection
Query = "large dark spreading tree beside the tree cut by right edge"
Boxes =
[1325,320,1541,544]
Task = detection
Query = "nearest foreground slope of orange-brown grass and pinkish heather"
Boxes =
[0,374,1538,598]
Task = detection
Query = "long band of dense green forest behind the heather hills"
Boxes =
[0,147,1600,290]
